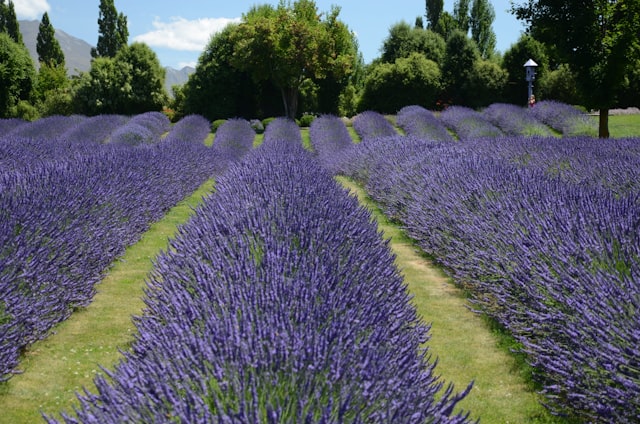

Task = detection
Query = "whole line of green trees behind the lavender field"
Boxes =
[0,0,640,137]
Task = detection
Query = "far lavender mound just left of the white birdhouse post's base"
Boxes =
[481,103,553,136]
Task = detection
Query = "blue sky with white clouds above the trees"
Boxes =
[13,0,524,69]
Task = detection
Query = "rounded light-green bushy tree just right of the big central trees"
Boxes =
[359,53,441,113]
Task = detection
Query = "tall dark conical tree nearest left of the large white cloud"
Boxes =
[91,0,129,58]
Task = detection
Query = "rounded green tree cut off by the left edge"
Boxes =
[0,33,36,118]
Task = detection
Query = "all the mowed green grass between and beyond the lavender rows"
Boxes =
[0,115,640,424]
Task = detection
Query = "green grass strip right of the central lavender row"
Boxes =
[337,177,562,424]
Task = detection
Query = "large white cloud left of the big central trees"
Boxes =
[133,17,240,51]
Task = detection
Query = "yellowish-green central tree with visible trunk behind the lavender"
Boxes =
[231,0,354,118]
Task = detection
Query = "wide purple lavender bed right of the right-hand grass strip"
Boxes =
[316,113,640,423]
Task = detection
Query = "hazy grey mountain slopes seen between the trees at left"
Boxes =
[19,21,195,94]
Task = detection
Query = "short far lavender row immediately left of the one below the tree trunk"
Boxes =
[213,118,256,160]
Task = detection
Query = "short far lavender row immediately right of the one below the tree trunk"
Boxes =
[309,115,353,172]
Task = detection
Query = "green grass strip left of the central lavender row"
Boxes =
[0,180,214,424]
